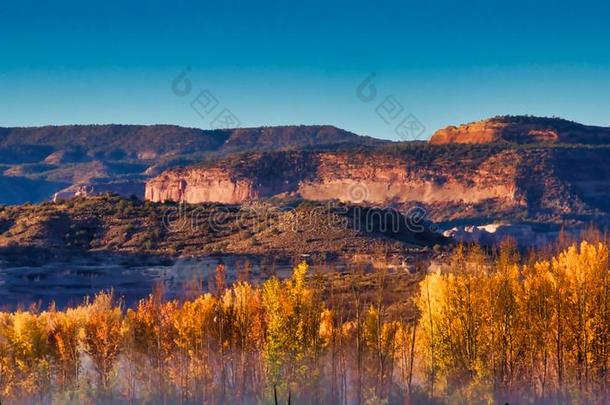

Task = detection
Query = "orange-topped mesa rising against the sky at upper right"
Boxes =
[430,116,610,145]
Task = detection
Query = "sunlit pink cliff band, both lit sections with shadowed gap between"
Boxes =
[146,153,522,204]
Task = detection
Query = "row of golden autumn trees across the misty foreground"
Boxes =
[0,238,610,404]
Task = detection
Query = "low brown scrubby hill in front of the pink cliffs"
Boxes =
[0,195,448,264]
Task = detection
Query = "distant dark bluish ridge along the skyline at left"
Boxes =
[0,124,381,163]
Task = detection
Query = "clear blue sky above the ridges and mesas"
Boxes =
[0,0,610,138]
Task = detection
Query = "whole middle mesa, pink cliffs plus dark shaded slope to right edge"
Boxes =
[146,145,610,226]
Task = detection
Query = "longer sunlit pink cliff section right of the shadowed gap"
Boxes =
[296,153,516,205]
